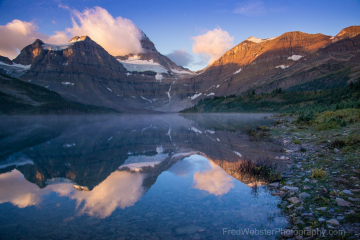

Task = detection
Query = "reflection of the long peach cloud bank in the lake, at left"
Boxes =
[0,170,146,218]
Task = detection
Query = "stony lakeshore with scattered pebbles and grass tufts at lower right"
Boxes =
[269,115,360,239]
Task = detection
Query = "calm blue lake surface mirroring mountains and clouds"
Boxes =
[0,114,286,239]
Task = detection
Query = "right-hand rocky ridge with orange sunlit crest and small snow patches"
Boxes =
[187,26,360,96]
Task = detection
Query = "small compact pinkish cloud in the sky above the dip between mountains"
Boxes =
[192,27,234,64]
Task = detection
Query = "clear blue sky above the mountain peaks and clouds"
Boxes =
[0,0,360,70]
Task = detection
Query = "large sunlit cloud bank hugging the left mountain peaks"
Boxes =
[0,5,143,58]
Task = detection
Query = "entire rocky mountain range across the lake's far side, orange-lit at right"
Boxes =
[0,26,360,112]
